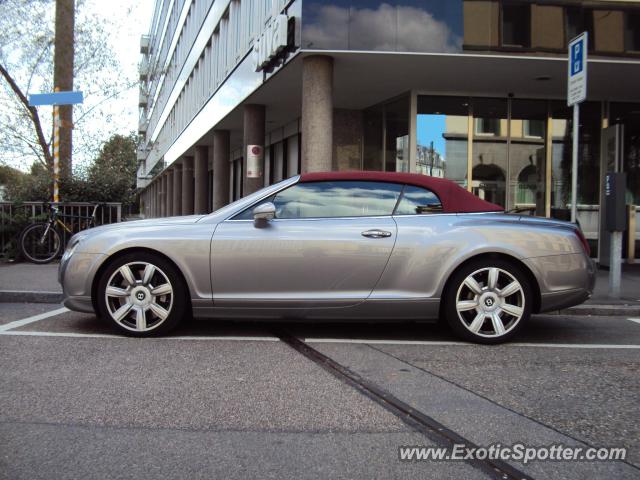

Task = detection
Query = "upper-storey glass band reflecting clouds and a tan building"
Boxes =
[301,0,640,55]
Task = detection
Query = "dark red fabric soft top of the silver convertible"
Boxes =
[300,171,504,213]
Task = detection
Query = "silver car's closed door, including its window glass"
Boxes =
[211,181,402,308]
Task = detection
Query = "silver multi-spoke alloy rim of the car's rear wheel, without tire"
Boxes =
[456,267,525,338]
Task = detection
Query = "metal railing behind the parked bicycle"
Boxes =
[0,202,122,257]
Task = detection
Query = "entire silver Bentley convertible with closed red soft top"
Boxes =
[59,172,594,343]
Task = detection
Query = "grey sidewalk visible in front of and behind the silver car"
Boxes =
[0,263,640,316]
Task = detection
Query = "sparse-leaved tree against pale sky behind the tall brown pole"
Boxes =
[0,0,137,175]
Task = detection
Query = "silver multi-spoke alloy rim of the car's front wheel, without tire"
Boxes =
[104,262,173,332]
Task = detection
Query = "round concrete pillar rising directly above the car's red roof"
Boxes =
[301,55,333,173]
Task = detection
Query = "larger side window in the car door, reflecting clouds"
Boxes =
[273,181,402,219]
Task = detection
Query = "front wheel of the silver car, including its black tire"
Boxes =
[95,252,190,337]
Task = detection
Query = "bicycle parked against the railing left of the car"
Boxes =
[18,203,101,264]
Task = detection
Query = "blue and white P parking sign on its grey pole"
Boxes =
[567,32,588,222]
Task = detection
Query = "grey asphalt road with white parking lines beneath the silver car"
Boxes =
[0,303,640,480]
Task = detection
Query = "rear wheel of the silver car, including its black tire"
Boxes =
[443,259,533,344]
